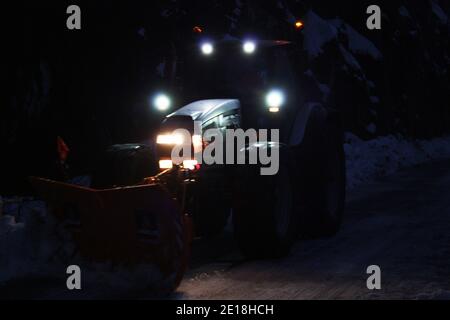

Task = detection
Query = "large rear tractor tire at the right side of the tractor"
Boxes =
[294,107,346,238]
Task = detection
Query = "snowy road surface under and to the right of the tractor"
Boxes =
[174,160,450,299]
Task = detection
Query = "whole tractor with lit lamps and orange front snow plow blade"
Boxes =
[32,39,345,288]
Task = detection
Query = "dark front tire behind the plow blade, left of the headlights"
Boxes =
[92,144,157,189]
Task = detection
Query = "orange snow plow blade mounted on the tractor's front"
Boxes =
[31,177,191,286]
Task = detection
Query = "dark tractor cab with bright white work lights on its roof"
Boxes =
[180,39,297,128]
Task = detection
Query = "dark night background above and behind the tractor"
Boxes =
[0,0,450,194]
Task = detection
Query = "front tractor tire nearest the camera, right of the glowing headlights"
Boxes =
[232,149,298,259]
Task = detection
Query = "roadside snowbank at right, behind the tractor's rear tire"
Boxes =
[344,133,450,189]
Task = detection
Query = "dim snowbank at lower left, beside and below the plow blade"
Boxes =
[0,199,173,293]
